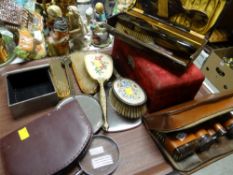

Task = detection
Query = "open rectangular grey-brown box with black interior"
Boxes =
[6,65,58,118]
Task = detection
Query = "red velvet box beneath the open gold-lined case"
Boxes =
[112,38,204,112]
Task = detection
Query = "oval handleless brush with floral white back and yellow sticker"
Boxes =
[109,78,147,119]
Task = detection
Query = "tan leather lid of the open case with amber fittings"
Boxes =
[144,90,233,132]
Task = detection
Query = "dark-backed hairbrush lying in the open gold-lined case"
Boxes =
[116,15,196,55]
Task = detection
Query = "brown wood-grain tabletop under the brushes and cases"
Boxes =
[0,59,172,175]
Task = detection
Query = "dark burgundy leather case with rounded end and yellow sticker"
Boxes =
[1,101,92,175]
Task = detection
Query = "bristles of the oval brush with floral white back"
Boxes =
[109,88,147,119]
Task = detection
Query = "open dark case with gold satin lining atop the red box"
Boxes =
[106,0,231,69]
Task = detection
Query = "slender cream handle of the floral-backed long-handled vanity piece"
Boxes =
[99,80,109,131]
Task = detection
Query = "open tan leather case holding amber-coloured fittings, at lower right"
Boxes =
[143,90,233,174]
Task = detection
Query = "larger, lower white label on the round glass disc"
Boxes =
[91,155,113,169]
